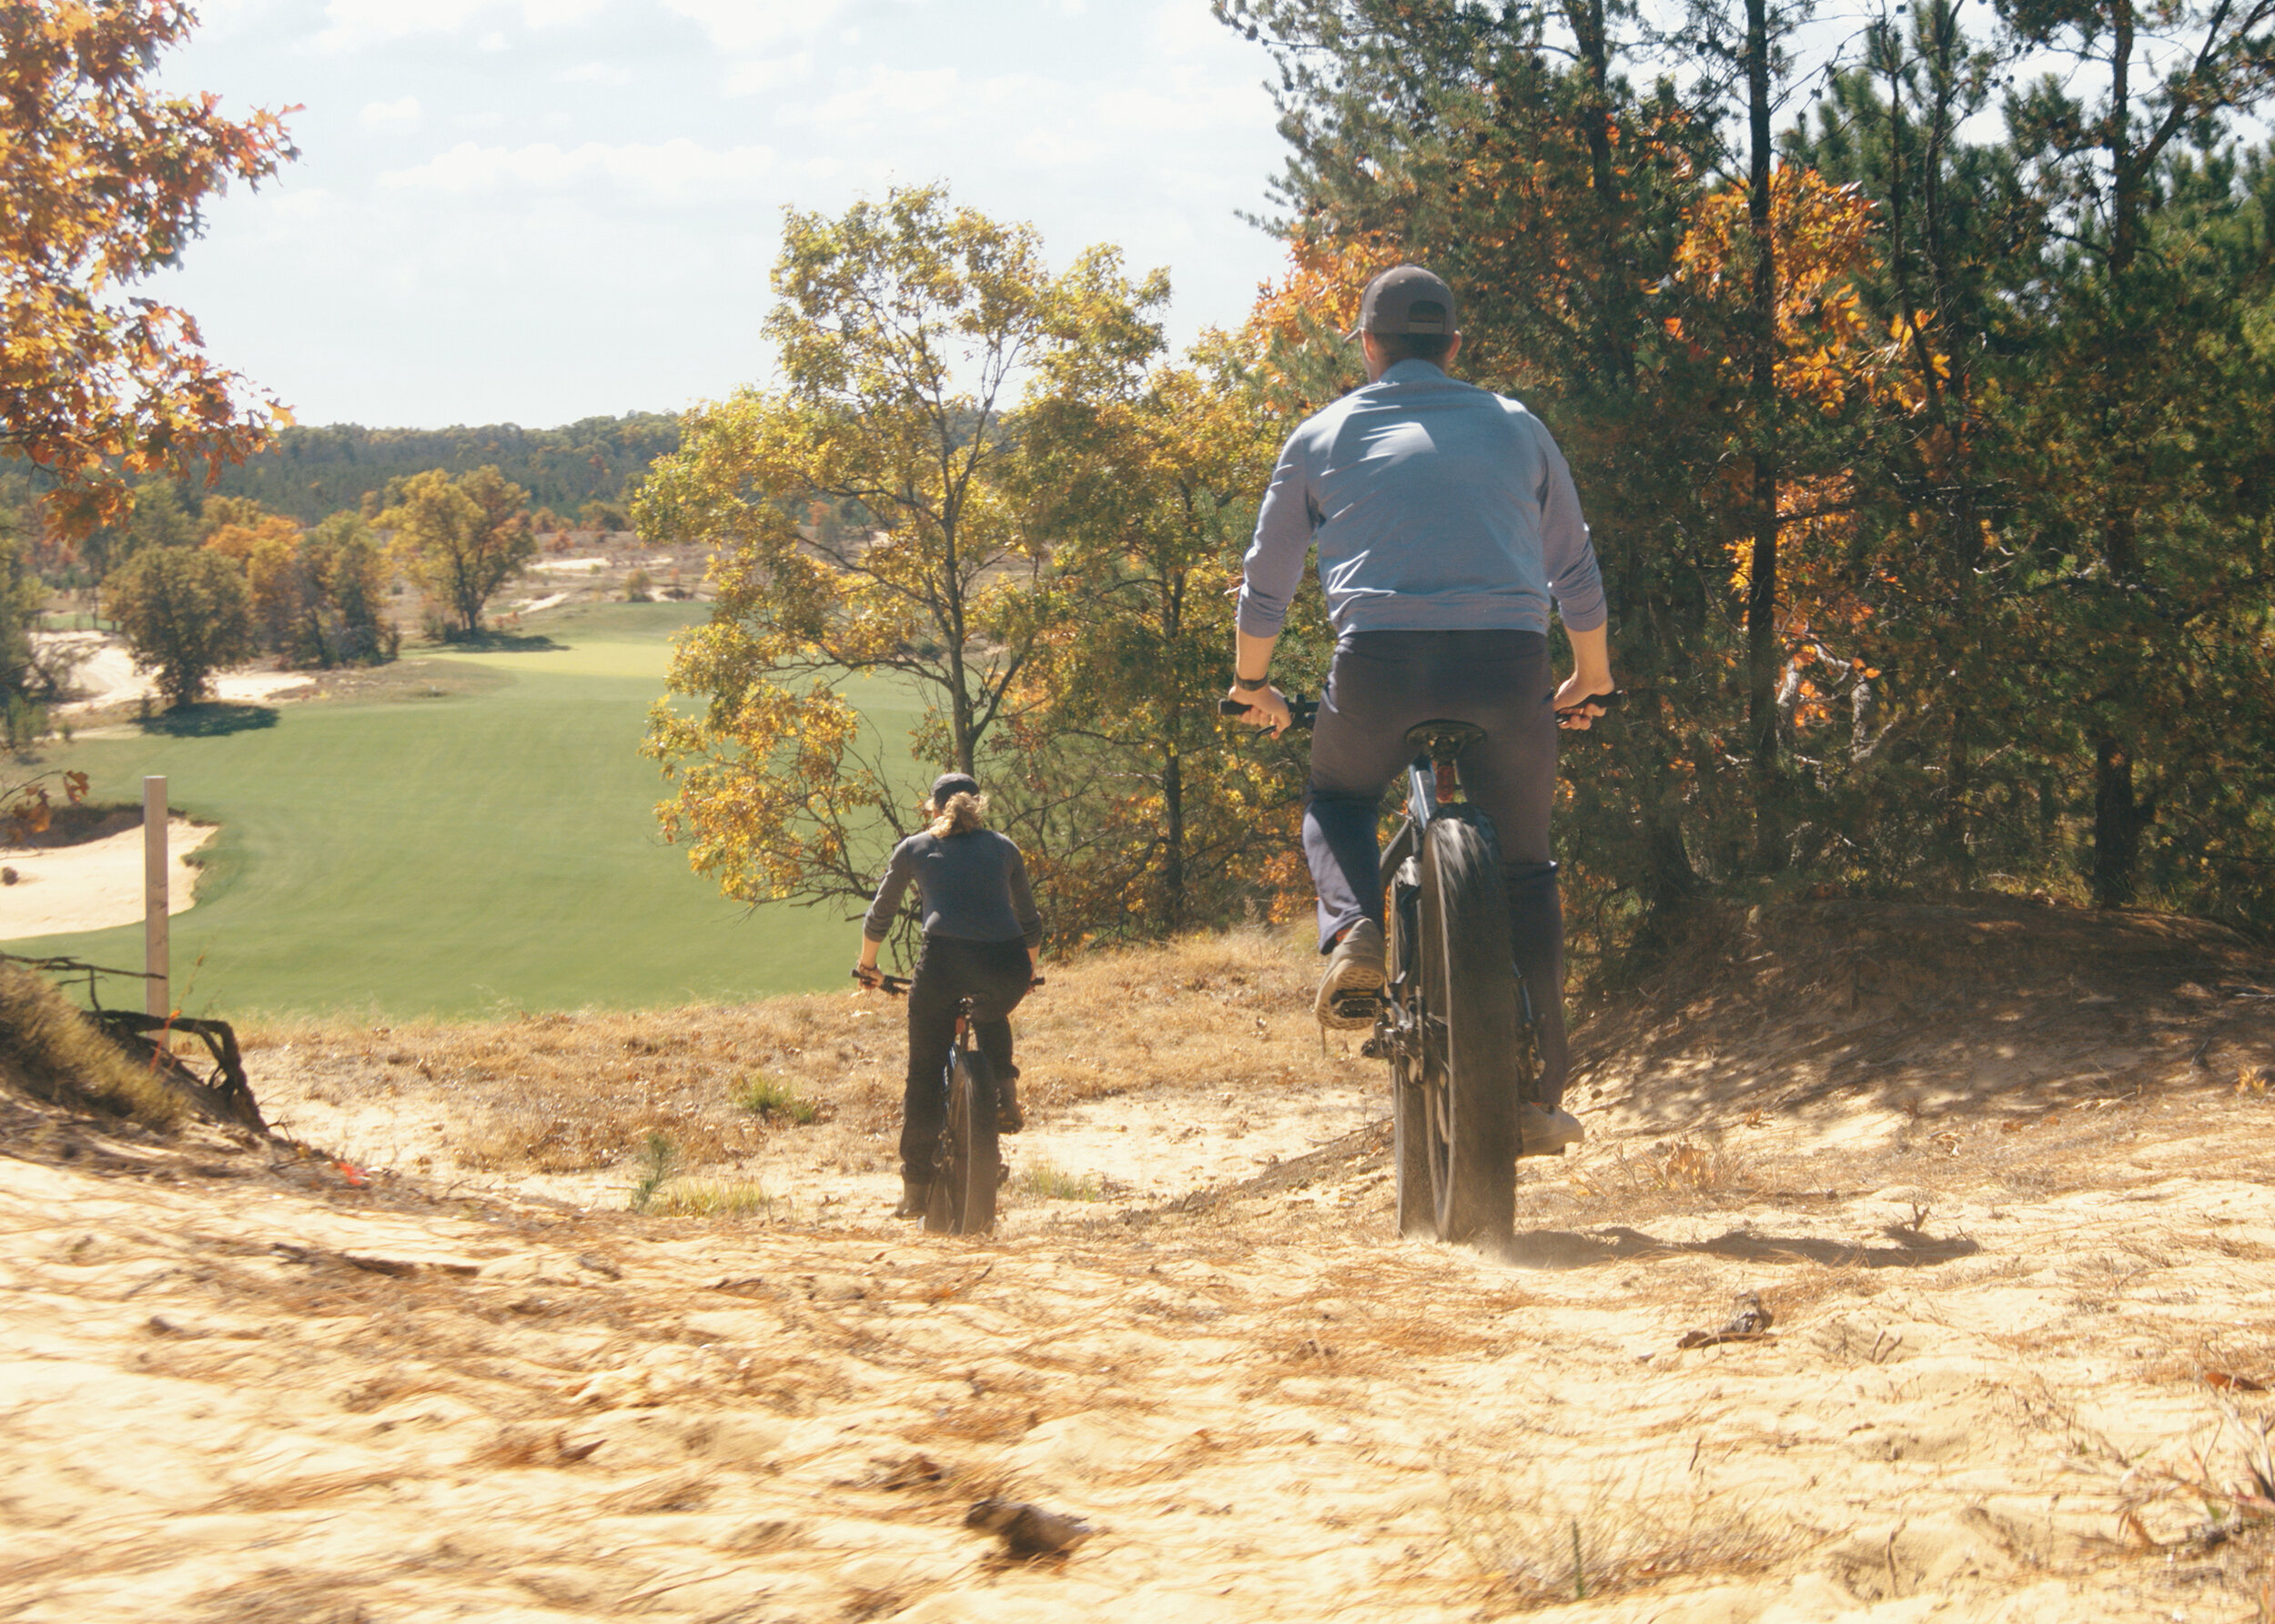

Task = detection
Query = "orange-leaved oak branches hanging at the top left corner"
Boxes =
[0,0,296,535]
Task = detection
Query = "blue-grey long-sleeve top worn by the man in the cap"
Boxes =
[1240,362,1606,637]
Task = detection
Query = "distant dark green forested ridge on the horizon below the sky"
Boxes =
[191,412,681,526]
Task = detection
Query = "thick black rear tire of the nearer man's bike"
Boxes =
[1401,810,1524,1245]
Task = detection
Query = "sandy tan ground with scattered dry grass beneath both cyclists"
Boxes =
[0,905,2275,1624]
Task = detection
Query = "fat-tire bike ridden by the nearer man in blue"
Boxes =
[1218,694,1620,1246]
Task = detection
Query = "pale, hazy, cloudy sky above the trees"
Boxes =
[153,0,1281,428]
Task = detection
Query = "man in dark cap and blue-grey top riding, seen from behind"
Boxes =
[1228,267,1613,1155]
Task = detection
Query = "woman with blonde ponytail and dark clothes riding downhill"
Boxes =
[854,773,1042,1217]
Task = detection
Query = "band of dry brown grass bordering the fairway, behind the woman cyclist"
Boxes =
[241,928,1356,1213]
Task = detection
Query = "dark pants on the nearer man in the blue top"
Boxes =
[1304,632,1565,1105]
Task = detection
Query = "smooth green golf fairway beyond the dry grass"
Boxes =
[7,603,917,1019]
